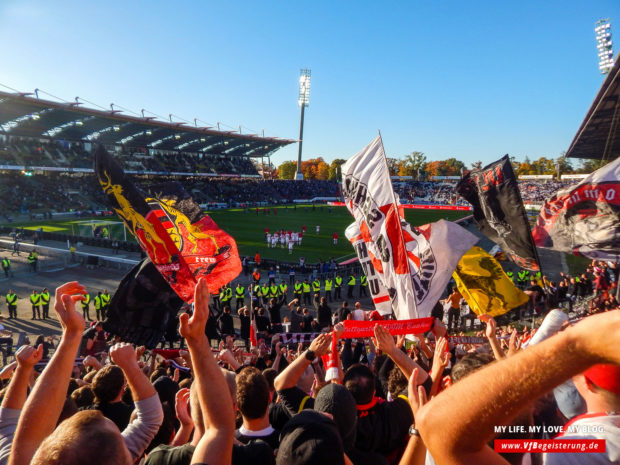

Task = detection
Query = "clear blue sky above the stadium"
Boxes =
[0,0,620,168]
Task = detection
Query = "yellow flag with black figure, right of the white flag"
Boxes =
[452,247,529,316]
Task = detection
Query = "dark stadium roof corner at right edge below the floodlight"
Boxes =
[566,55,620,160]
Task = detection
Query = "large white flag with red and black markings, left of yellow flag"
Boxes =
[342,136,478,320]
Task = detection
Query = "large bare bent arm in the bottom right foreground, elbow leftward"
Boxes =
[416,310,620,465]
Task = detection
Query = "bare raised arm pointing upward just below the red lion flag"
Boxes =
[179,278,235,465]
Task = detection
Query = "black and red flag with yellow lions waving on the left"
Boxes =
[95,147,241,302]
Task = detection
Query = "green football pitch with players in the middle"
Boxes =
[7,205,470,263]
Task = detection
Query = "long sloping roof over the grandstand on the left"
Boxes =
[0,91,296,157]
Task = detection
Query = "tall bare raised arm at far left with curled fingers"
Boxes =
[9,281,86,465]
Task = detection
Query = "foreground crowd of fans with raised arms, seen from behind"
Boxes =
[0,263,620,465]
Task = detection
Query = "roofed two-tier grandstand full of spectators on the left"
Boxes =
[0,92,324,216]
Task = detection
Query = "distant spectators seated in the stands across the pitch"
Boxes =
[0,136,596,213]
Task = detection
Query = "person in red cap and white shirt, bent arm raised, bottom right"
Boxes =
[415,310,620,465]
